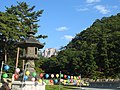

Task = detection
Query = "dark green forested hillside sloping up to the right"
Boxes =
[41,13,120,79]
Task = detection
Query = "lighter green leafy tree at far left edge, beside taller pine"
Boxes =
[0,12,21,63]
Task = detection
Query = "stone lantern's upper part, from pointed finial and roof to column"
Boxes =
[17,29,44,72]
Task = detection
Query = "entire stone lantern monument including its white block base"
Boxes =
[12,25,45,90]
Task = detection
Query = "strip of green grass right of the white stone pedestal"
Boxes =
[45,85,79,90]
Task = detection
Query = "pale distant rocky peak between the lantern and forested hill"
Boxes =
[42,48,57,58]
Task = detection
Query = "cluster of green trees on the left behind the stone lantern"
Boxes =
[0,2,44,66]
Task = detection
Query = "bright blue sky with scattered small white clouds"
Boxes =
[0,0,120,49]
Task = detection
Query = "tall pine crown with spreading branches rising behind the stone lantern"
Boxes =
[6,2,47,38]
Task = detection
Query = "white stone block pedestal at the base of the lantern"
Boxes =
[12,81,46,90]
